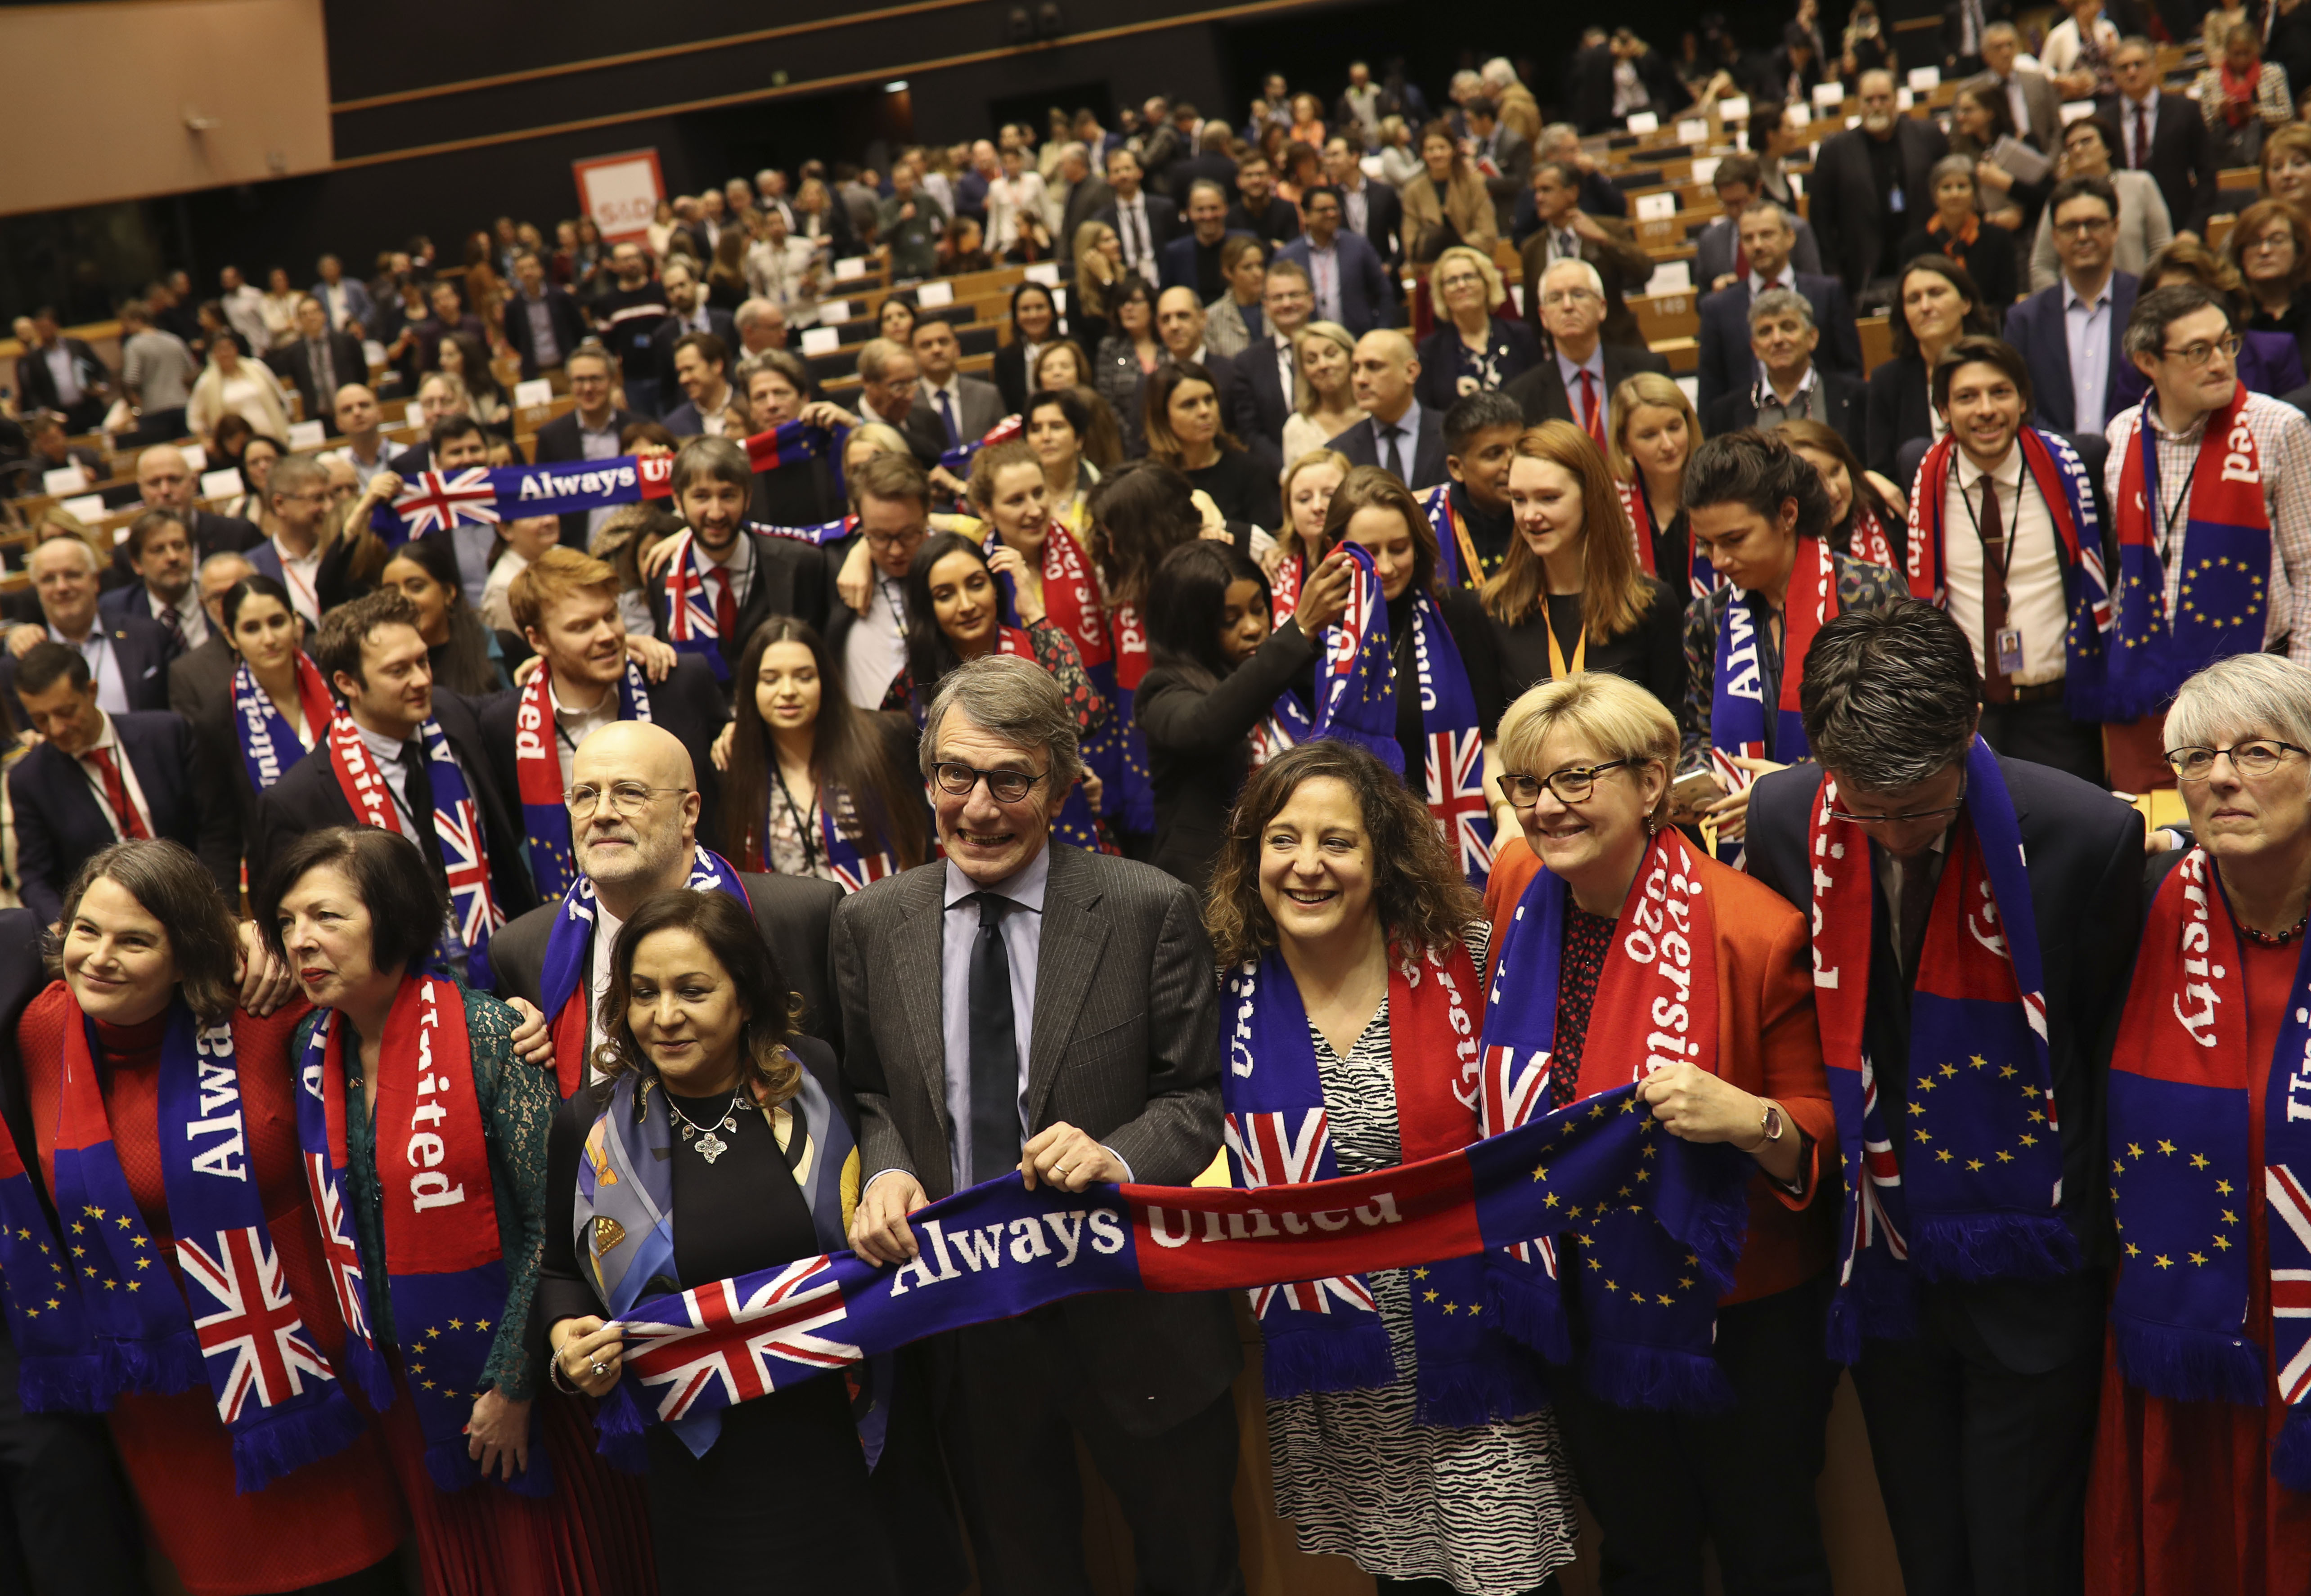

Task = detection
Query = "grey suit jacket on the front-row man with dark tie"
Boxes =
[834,843,1243,1435]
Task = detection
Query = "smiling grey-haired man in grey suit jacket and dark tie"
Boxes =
[834,656,1243,1596]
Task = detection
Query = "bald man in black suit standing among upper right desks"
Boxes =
[1805,72,1951,300]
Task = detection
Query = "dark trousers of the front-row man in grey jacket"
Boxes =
[938,1309,1243,1596]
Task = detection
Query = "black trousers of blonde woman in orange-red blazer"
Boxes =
[1556,1275,1839,1596]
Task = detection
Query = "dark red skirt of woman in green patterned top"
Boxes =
[381,1360,659,1596]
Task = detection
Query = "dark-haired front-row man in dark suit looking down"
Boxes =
[1747,601,2142,1596]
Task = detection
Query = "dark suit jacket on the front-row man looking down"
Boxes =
[1747,755,2142,1374]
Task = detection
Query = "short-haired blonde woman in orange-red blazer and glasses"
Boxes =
[1484,672,1837,1594]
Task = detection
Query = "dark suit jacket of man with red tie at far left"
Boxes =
[7,709,240,924]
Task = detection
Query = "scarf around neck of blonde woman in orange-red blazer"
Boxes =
[1484,827,1754,1411]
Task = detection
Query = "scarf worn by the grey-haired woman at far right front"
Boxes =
[2110,847,2311,1490]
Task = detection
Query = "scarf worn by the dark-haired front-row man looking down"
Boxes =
[1812,737,2077,1363]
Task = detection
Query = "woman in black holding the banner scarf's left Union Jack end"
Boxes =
[536,892,901,1596]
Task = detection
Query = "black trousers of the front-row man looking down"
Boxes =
[1853,1275,2103,1596]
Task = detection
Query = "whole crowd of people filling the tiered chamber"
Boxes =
[0,0,2311,1596]
